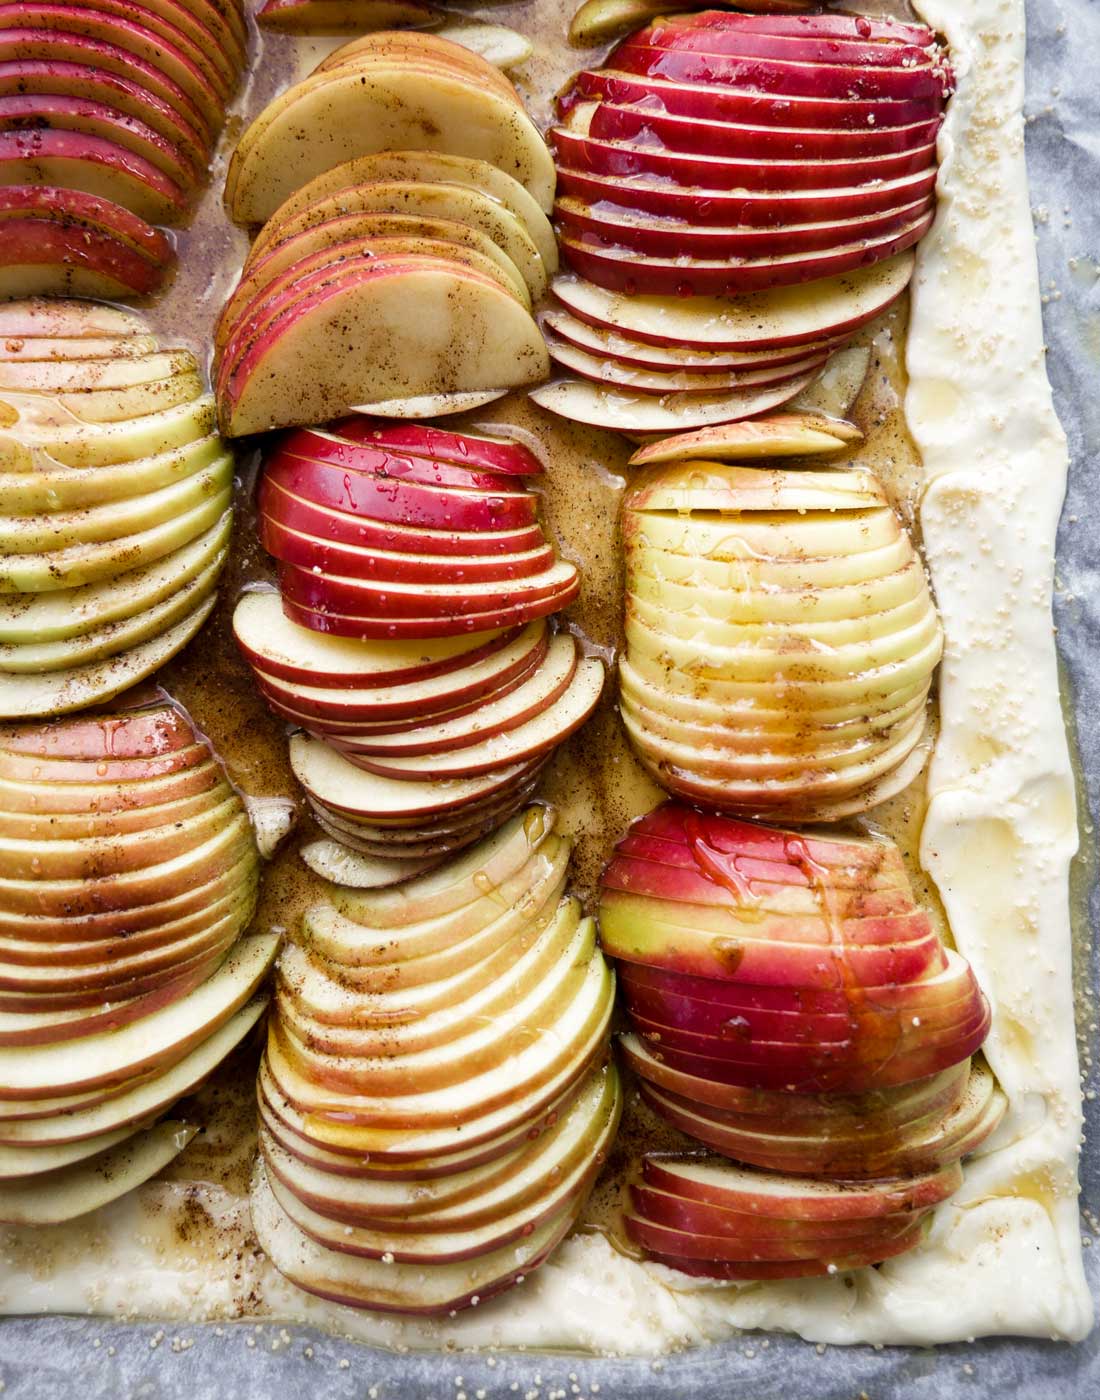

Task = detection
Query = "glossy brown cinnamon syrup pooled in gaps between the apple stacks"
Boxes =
[0,0,949,1316]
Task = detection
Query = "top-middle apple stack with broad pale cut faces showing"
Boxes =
[217,32,556,435]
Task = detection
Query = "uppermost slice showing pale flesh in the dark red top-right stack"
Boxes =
[553,253,912,350]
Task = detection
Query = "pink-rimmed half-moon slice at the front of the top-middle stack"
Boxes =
[221,256,549,435]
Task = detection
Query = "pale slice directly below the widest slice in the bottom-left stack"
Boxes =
[0,995,267,1142]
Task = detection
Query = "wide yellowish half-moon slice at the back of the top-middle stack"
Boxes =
[225,59,554,224]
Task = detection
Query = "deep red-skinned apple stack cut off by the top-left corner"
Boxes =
[0,0,248,297]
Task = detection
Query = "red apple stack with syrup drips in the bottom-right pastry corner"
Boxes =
[599,804,1005,1278]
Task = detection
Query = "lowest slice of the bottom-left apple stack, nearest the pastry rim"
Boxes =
[0,1121,199,1225]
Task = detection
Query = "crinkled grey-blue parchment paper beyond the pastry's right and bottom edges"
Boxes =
[0,0,1100,1400]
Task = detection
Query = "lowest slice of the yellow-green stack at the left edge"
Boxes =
[0,594,217,720]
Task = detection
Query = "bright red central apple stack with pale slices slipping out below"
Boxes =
[234,417,605,882]
